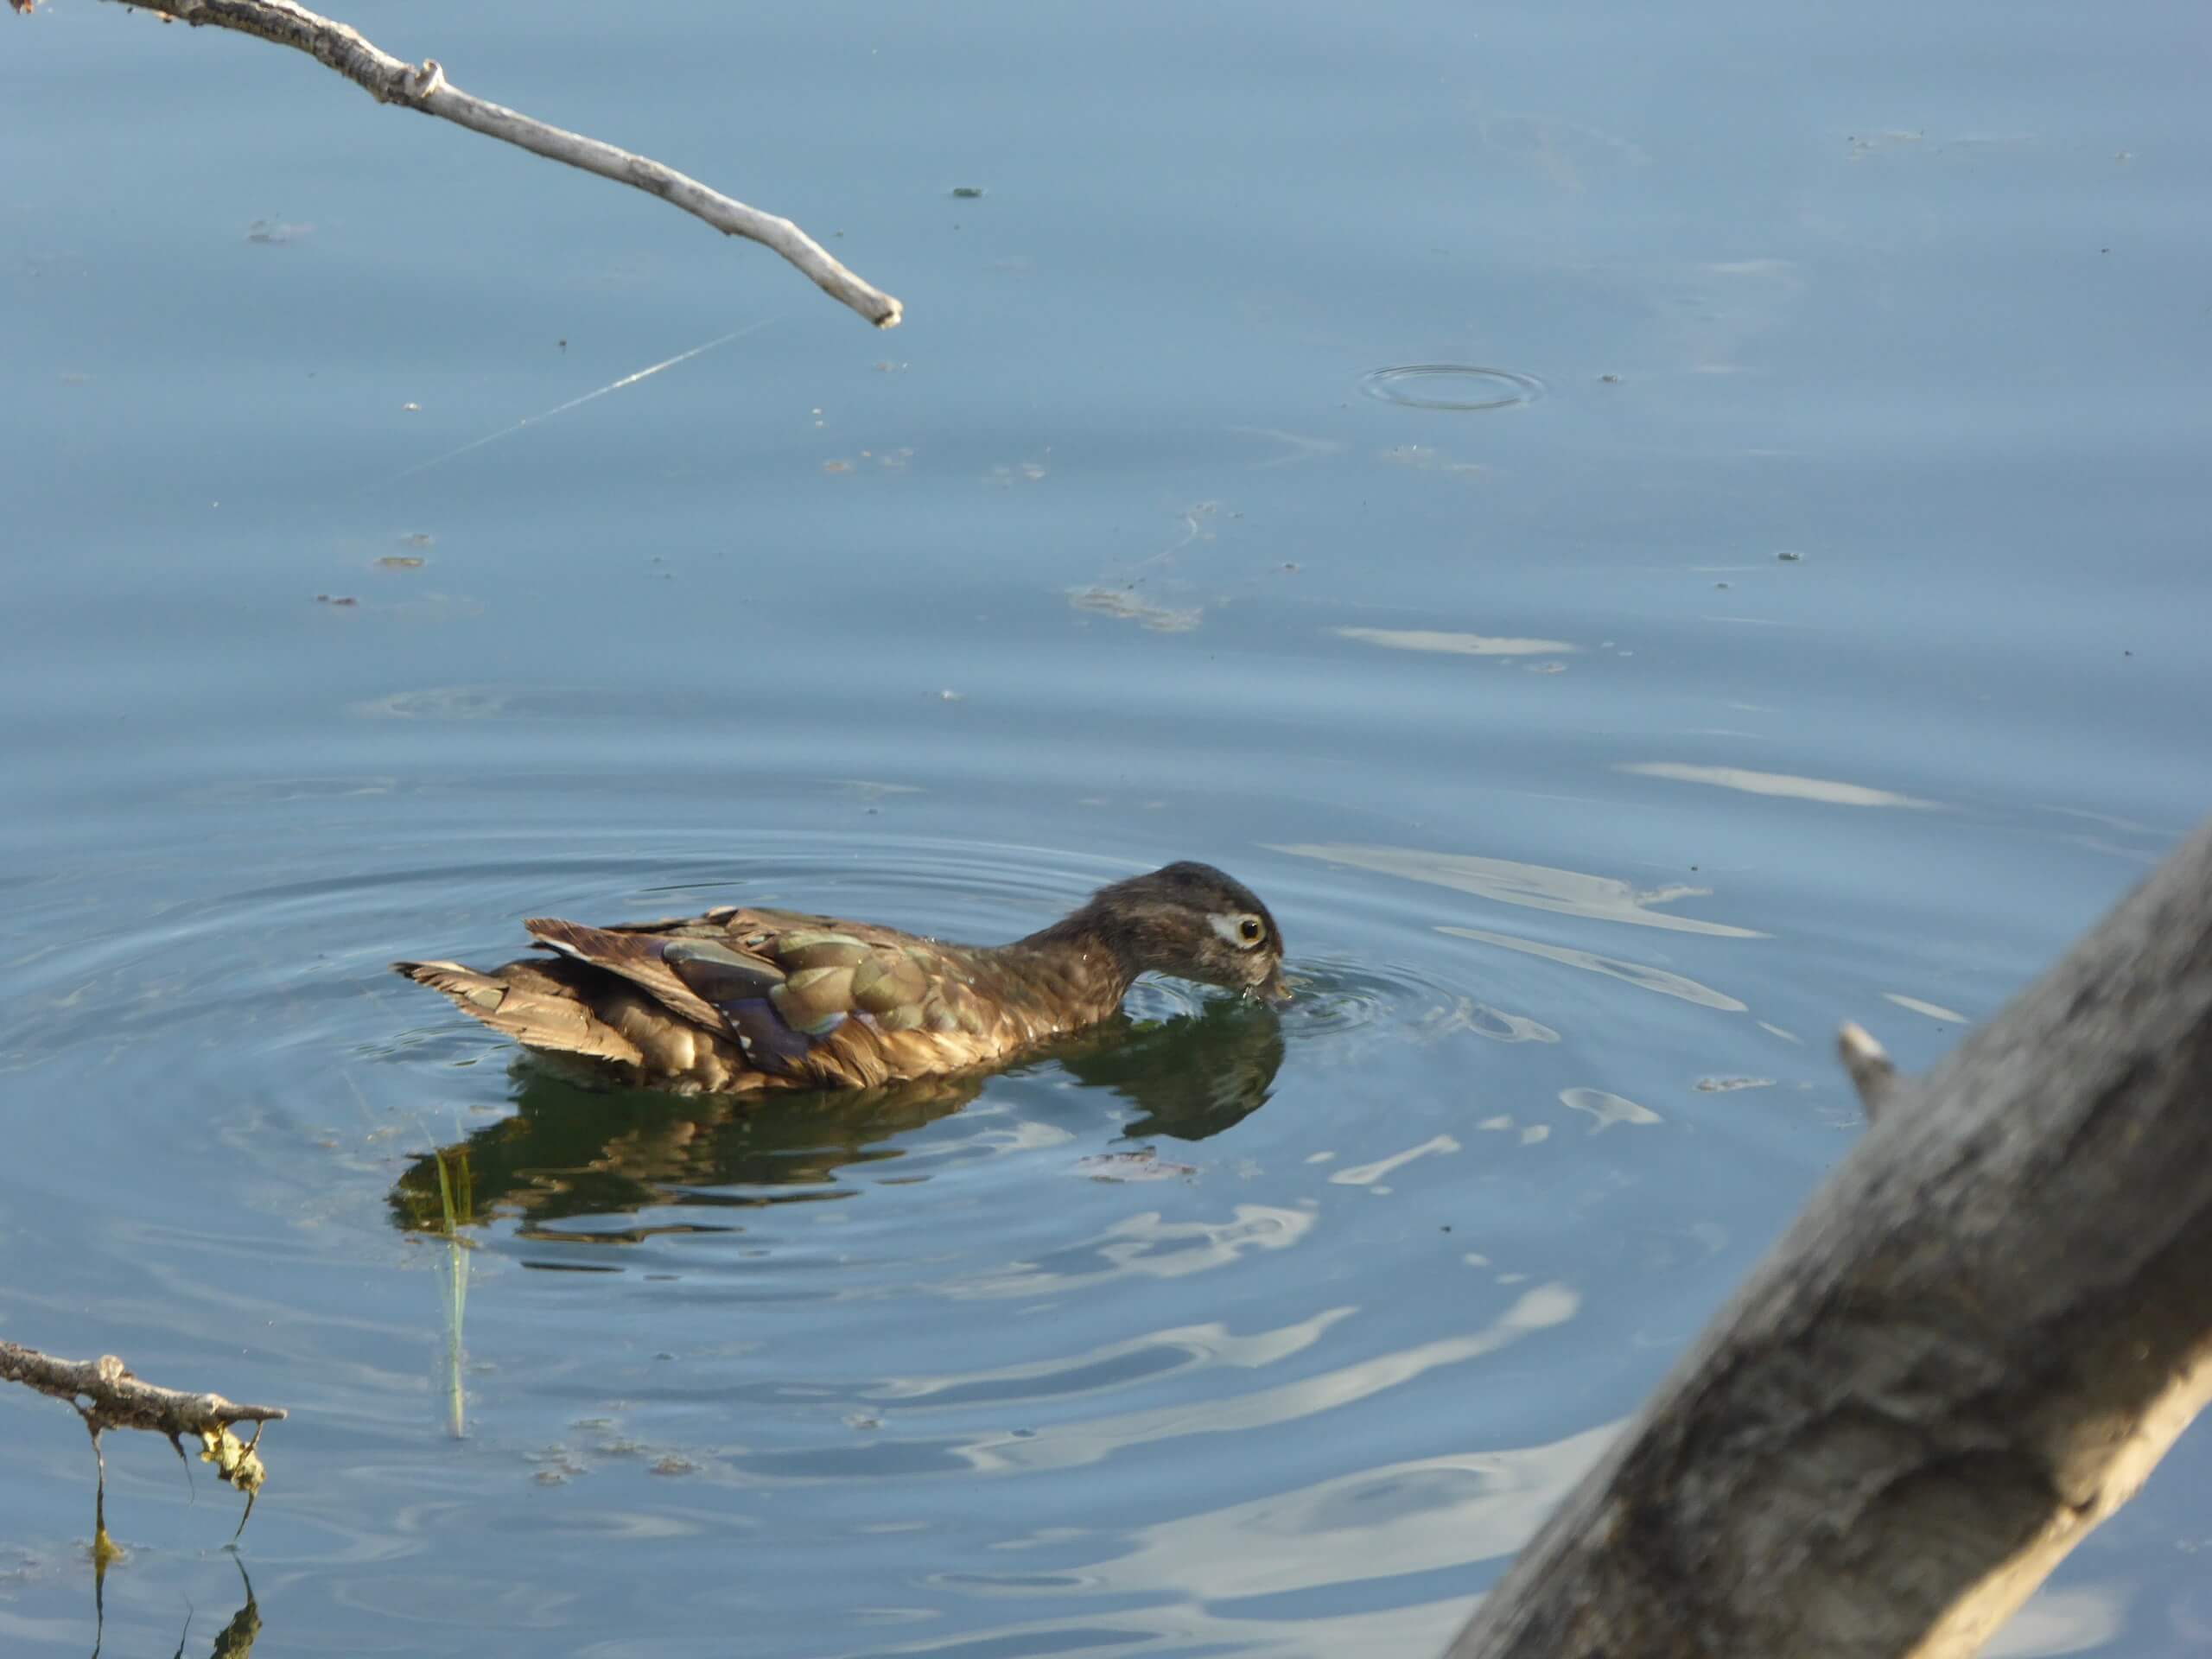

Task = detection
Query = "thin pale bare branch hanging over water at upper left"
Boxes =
[81,0,900,327]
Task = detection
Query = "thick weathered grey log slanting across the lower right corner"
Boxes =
[1449,821,2212,1659]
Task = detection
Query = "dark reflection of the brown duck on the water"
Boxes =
[390,998,1283,1243]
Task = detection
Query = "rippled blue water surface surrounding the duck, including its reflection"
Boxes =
[0,0,2212,1659]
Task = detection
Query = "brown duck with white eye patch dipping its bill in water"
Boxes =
[391,862,1289,1095]
